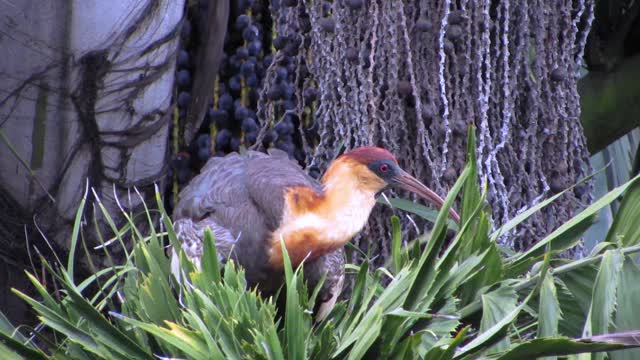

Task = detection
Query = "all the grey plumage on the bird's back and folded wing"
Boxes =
[173,149,322,293]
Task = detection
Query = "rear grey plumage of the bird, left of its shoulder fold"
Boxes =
[173,152,270,286]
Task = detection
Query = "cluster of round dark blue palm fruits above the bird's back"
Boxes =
[171,0,320,207]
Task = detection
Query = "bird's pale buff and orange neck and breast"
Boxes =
[269,159,386,268]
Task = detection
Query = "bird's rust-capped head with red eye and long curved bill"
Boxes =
[327,146,460,222]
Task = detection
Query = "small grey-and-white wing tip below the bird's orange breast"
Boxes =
[304,247,345,321]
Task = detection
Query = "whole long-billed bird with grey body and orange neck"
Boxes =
[171,146,460,321]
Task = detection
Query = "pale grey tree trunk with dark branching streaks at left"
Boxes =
[0,0,184,326]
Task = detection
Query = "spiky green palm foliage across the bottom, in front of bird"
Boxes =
[0,131,640,359]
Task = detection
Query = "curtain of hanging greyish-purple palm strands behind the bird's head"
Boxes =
[260,0,593,261]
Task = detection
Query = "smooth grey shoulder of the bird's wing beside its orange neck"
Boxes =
[247,149,322,231]
